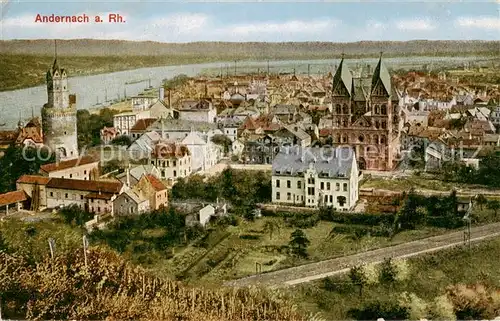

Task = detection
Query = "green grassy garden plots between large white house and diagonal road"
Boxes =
[169,217,446,284]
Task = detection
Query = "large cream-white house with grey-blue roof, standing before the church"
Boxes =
[272,146,359,211]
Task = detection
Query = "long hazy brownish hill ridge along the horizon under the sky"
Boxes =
[0,39,500,59]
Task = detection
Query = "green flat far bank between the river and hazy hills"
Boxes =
[0,51,495,92]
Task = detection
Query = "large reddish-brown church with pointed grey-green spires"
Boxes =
[331,55,402,170]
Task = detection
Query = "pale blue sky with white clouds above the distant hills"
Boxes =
[0,0,500,42]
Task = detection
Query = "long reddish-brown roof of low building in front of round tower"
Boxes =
[47,177,122,194]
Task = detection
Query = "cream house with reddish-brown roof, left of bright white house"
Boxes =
[150,141,192,186]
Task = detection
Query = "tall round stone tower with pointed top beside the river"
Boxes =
[42,44,78,159]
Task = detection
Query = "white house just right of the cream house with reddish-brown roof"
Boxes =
[181,132,223,172]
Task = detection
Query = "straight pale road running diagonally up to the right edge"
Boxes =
[225,223,500,287]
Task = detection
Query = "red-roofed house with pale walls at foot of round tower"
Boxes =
[40,156,99,180]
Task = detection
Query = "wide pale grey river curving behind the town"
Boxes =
[0,57,488,129]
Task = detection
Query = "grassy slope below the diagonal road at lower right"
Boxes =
[290,234,500,320]
